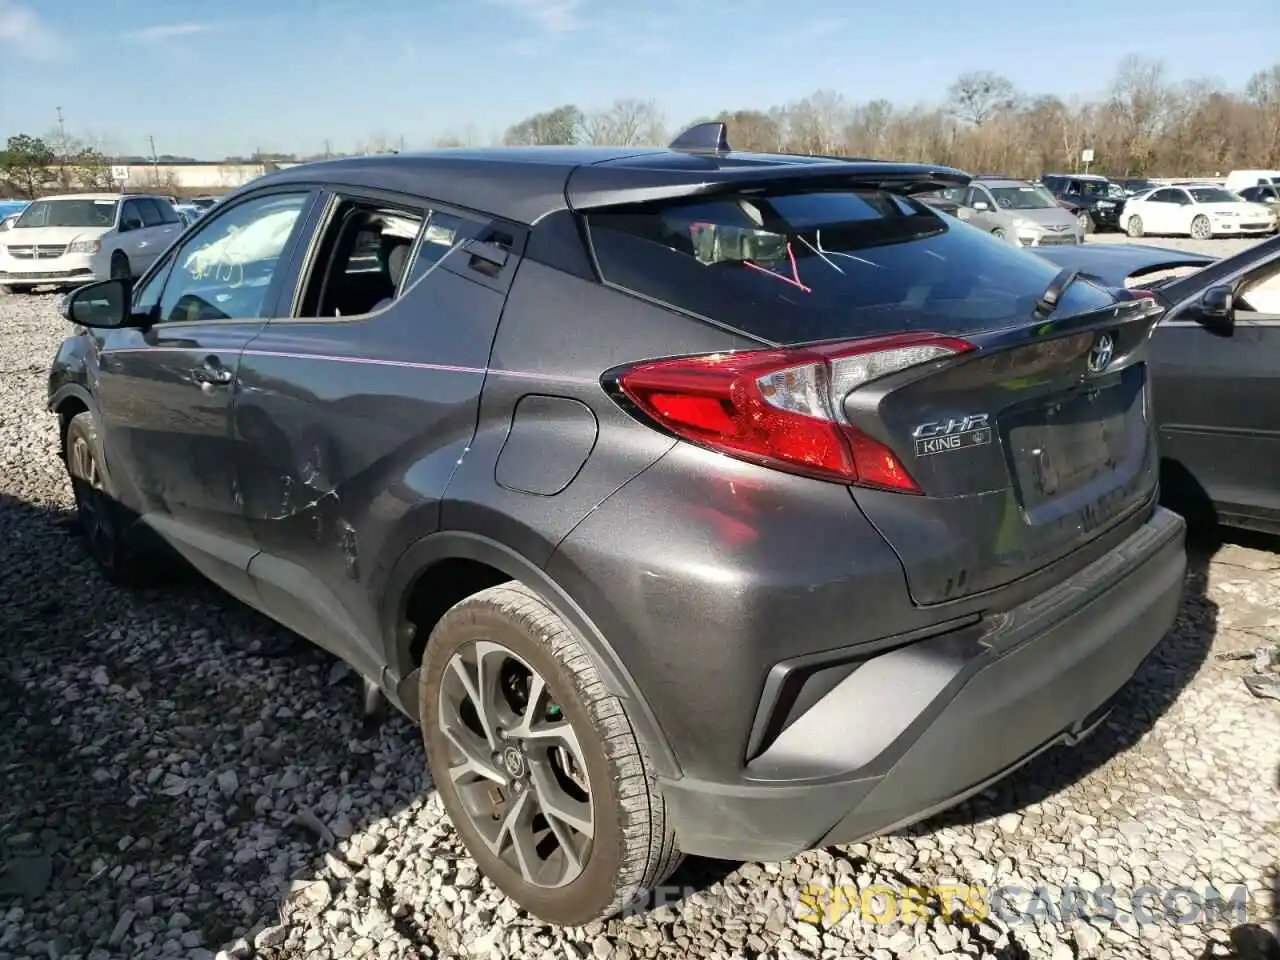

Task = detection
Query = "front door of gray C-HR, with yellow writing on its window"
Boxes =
[93,189,312,602]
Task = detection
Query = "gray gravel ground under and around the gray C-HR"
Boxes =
[0,245,1280,960]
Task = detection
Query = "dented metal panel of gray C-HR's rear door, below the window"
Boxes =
[234,270,503,678]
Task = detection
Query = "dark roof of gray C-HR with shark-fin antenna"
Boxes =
[246,124,970,224]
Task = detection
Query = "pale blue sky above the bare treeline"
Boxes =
[0,0,1280,157]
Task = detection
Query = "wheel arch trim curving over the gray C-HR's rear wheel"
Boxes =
[381,531,680,778]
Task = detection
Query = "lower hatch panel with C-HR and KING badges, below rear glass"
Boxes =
[845,301,1157,604]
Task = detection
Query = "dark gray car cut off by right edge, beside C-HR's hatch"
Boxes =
[1041,238,1280,534]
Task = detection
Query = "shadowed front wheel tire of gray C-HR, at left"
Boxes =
[63,412,154,586]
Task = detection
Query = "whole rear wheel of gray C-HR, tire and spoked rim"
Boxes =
[419,584,681,925]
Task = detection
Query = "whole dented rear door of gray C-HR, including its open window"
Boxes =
[233,186,518,681]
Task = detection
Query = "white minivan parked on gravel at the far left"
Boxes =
[0,193,184,293]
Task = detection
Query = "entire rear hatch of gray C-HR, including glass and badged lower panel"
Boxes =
[585,180,1158,604]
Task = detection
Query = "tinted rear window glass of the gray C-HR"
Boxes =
[586,191,1112,343]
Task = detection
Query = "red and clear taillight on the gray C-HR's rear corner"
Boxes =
[618,333,973,493]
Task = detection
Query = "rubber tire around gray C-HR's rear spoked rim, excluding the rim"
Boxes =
[419,584,682,925]
